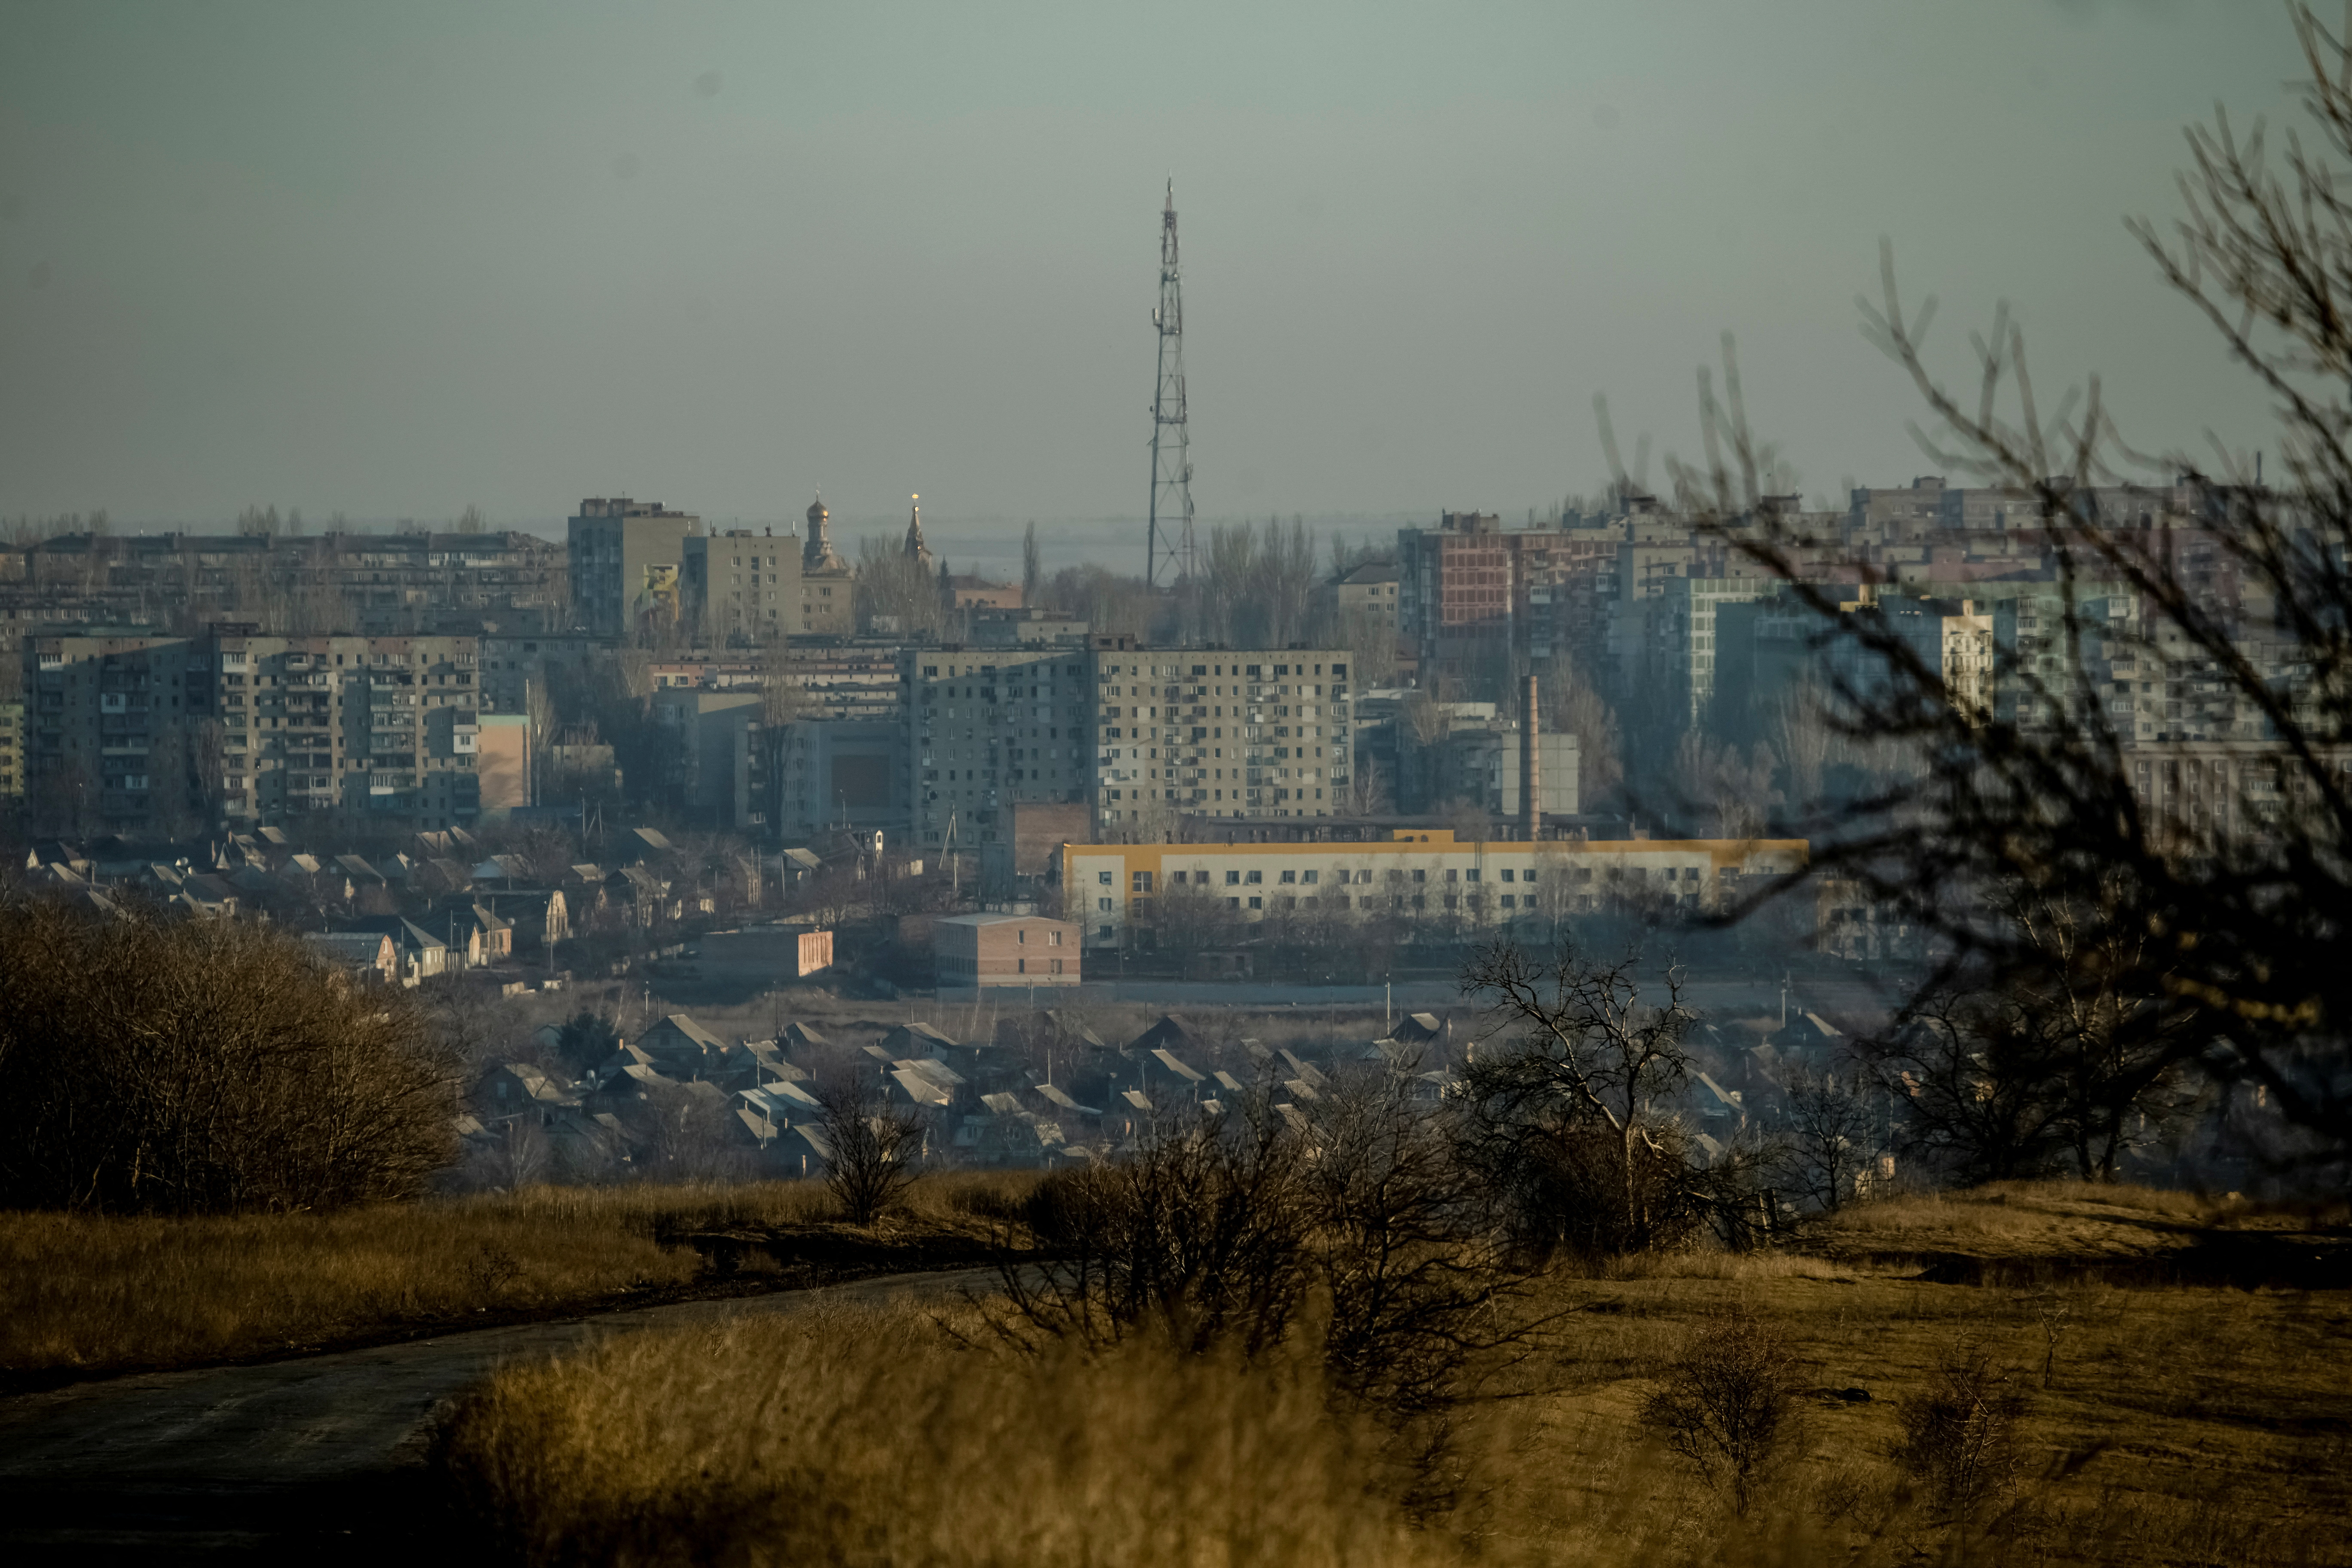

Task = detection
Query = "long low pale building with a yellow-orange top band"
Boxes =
[1061,827,1809,945]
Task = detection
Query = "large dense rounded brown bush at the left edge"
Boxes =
[0,903,456,1213]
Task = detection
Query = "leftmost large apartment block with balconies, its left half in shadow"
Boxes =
[24,625,512,837]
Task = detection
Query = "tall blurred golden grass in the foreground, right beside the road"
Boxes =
[442,1309,1446,1568]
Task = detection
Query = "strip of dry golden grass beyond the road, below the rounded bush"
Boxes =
[0,1173,1032,1380]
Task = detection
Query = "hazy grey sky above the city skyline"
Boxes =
[0,0,2298,550]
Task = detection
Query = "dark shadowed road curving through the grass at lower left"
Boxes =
[0,1269,995,1566]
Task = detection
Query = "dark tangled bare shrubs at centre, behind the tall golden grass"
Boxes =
[1000,1072,1538,1467]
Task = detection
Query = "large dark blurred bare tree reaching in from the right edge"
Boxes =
[1679,5,2352,1164]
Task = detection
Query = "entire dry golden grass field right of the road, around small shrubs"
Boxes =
[442,1185,2352,1566]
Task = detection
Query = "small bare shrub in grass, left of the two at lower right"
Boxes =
[1642,1307,1797,1514]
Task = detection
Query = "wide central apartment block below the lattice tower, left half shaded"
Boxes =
[901,637,1352,848]
